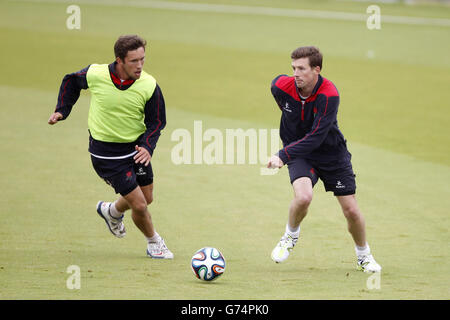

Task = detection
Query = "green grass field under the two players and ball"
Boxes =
[0,0,450,300]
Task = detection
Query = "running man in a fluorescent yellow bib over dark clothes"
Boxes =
[48,35,173,259]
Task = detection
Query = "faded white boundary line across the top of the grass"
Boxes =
[14,0,450,27]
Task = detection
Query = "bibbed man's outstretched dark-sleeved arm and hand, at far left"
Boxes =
[48,66,89,124]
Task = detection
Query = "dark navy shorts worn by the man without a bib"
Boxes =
[287,152,356,196]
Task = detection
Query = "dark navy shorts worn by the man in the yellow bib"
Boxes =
[91,155,153,196]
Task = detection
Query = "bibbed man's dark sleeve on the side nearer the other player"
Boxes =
[139,85,166,156]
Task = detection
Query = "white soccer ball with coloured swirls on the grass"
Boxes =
[191,247,225,281]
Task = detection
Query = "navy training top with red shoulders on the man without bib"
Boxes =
[271,75,347,164]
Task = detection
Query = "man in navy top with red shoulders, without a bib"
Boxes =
[267,47,381,272]
